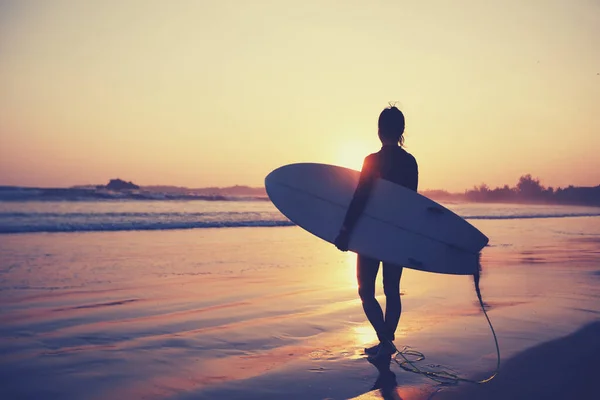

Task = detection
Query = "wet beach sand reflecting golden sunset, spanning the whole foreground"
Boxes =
[0,218,600,400]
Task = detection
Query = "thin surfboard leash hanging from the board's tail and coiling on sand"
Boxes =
[394,261,500,385]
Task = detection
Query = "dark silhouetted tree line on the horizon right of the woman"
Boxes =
[423,174,600,206]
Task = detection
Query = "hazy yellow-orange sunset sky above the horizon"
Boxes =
[0,0,600,191]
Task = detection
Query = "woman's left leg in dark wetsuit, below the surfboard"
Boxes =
[356,254,390,342]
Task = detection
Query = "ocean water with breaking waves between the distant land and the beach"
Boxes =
[0,199,600,234]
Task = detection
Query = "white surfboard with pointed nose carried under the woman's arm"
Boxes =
[265,163,488,275]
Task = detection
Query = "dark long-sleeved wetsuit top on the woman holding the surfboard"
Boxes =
[343,145,419,231]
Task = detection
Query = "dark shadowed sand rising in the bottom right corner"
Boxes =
[355,322,600,400]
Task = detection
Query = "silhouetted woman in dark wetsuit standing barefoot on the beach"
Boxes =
[335,106,419,361]
